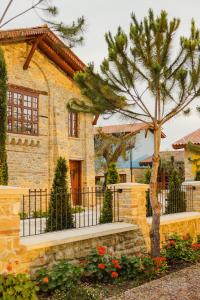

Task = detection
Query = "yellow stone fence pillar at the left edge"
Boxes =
[0,186,27,273]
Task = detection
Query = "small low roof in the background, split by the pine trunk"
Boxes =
[139,150,184,166]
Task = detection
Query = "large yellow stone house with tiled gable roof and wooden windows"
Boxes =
[0,26,95,193]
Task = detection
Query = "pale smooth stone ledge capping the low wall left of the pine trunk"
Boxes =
[20,222,138,250]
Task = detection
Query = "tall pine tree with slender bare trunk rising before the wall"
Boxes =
[68,9,200,257]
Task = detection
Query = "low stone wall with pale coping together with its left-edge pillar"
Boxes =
[0,186,146,273]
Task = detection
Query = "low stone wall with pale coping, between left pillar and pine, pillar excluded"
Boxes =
[11,223,146,273]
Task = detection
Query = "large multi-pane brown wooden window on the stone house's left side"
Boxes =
[7,90,38,135]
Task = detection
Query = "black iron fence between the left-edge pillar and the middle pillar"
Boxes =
[20,188,119,237]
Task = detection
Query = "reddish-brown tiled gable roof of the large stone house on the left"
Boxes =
[0,25,85,77]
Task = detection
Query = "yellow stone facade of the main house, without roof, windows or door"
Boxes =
[2,43,95,188]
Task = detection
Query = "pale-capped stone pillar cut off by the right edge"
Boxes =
[183,181,200,212]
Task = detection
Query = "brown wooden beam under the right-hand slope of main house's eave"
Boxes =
[38,41,75,78]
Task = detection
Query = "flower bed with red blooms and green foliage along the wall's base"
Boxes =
[0,234,200,300]
